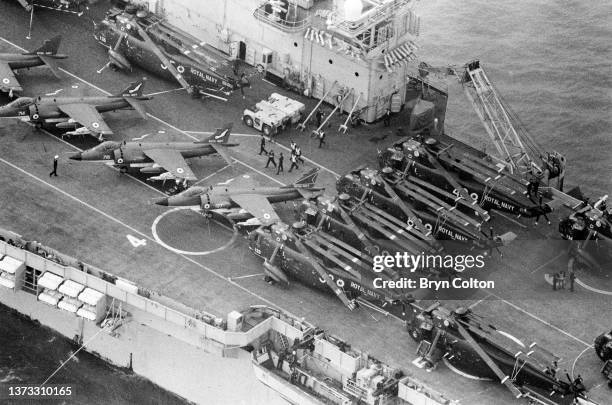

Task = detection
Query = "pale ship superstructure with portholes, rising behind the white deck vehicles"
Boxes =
[143,0,445,122]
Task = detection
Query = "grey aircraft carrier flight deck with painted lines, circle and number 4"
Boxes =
[0,2,612,404]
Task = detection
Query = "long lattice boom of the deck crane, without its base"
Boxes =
[461,61,542,175]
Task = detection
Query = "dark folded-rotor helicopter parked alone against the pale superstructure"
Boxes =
[94,5,249,101]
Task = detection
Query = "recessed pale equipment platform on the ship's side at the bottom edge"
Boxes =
[253,322,459,405]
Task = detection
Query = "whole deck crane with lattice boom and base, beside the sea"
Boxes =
[454,60,565,191]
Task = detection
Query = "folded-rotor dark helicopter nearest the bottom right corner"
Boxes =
[407,302,593,405]
